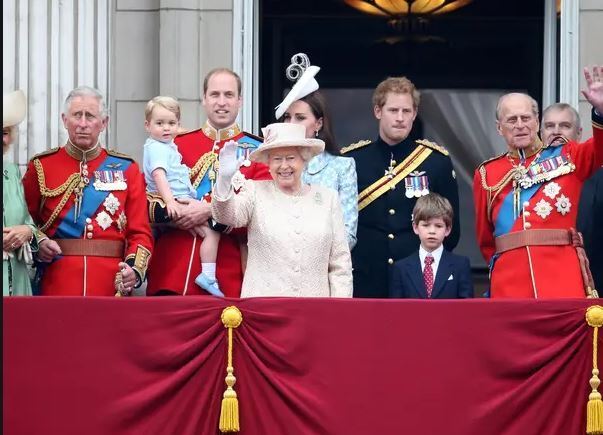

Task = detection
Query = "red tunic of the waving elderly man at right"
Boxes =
[473,111,603,298]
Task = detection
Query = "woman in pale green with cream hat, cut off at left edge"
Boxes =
[2,91,36,296]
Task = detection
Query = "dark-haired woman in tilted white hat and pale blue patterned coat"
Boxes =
[275,53,358,250]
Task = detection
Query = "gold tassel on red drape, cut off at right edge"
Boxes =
[586,305,603,435]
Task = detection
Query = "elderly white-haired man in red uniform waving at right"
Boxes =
[473,67,603,298]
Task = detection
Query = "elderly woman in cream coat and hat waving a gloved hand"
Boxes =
[212,124,352,297]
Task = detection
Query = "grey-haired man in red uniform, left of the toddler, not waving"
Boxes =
[23,86,153,296]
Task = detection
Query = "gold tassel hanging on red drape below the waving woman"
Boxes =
[220,306,243,432]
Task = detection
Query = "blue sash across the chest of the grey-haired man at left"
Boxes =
[54,156,132,239]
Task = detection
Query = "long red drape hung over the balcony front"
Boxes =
[3,297,593,435]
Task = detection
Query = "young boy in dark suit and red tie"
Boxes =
[389,193,473,299]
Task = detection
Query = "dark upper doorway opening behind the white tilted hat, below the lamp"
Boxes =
[260,0,544,125]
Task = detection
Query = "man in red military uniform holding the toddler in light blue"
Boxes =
[147,68,270,297]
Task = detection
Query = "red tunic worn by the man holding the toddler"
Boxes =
[147,122,270,297]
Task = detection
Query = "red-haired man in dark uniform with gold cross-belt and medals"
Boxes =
[341,77,460,298]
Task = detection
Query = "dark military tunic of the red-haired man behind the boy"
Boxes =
[342,137,460,298]
